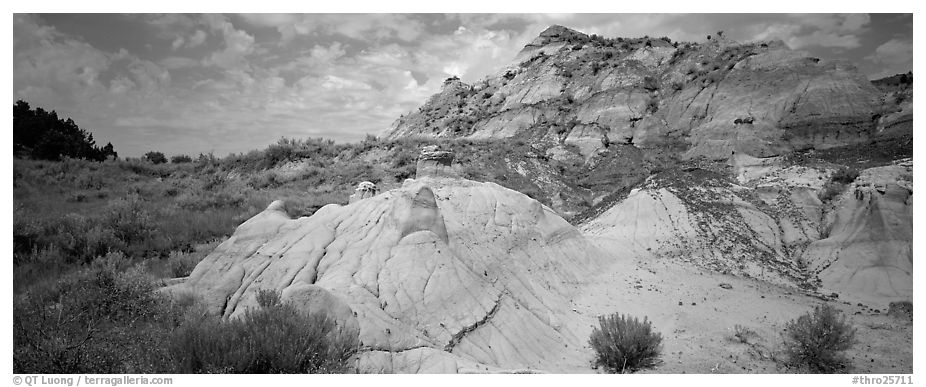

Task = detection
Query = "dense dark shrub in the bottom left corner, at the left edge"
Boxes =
[13,264,177,373]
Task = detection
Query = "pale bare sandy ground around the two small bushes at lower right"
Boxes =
[570,237,913,374]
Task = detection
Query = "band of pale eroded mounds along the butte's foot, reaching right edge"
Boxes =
[580,155,913,307]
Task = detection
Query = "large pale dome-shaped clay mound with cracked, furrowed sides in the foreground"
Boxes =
[171,148,605,372]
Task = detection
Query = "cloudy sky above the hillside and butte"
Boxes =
[12,14,913,156]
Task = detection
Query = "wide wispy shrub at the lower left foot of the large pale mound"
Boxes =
[169,298,356,374]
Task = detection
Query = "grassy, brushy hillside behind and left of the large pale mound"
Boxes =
[13,126,912,373]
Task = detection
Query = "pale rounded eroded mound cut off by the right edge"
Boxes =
[804,161,913,305]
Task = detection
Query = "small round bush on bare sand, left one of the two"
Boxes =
[589,313,662,373]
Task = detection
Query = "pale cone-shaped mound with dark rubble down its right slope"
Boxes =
[581,170,816,286]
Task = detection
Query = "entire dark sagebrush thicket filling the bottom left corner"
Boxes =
[13,262,356,374]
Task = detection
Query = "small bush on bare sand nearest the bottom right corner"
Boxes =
[784,305,855,373]
